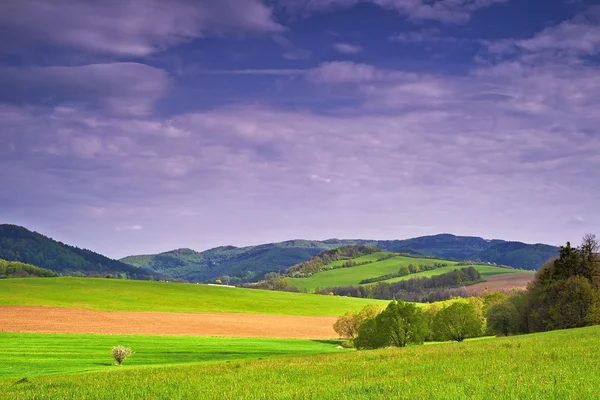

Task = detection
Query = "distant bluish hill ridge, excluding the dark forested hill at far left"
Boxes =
[121,234,559,283]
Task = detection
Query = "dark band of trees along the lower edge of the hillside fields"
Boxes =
[319,267,481,301]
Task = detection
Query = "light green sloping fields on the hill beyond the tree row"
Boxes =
[289,252,532,290]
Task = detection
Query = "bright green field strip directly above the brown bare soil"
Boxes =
[0,277,387,316]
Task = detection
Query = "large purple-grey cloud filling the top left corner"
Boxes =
[0,0,284,57]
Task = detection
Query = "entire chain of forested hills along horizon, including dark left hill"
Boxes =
[0,224,558,283]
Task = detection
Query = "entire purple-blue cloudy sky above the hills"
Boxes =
[0,0,600,258]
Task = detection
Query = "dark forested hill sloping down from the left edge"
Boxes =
[0,225,156,279]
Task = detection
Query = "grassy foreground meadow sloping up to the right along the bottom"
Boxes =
[0,327,600,400]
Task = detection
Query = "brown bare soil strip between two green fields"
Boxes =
[0,307,337,339]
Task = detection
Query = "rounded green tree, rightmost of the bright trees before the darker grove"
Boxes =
[433,302,483,342]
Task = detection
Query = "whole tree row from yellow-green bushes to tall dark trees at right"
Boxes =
[334,235,600,349]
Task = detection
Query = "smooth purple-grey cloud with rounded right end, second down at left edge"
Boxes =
[0,63,169,116]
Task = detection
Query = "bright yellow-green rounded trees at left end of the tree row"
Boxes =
[334,298,485,349]
